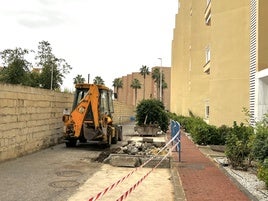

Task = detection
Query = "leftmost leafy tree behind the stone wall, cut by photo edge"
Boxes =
[0,48,32,85]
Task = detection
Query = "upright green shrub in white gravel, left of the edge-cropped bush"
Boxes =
[225,122,253,170]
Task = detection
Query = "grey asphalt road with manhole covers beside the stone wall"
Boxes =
[0,124,138,201]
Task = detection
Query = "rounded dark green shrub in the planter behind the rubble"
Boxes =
[136,99,169,132]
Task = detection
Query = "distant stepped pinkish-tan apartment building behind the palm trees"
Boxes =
[114,66,171,110]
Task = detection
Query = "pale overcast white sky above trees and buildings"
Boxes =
[0,0,178,90]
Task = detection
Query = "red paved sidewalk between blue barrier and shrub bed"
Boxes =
[173,133,251,201]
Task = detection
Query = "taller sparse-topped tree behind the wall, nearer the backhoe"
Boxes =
[35,41,72,90]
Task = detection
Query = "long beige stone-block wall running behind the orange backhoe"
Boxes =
[0,84,134,161]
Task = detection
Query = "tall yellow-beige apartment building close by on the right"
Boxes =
[170,0,268,126]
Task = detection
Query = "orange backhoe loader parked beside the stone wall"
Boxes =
[63,84,122,147]
